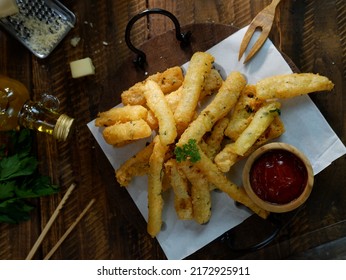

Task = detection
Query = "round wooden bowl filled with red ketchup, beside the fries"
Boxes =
[243,143,313,212]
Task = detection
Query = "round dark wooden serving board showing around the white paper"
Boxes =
[97,23,298,255]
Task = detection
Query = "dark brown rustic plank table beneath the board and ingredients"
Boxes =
[0,0,346,259]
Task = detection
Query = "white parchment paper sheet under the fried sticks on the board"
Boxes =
[88,28,346,259]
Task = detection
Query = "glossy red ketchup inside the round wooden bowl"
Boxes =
[250,149,308,204]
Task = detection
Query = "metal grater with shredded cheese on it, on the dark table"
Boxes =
[0,0,76,58]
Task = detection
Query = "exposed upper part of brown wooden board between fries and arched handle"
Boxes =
[99,23,237,111]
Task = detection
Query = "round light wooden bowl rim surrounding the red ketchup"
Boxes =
[243,142,314,213]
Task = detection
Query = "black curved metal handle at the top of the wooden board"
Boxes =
[125,8,191,68]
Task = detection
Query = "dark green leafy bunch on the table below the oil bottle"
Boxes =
[0,129,59,223]
